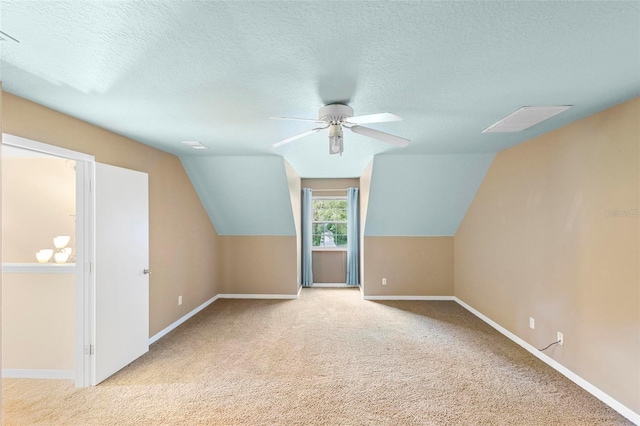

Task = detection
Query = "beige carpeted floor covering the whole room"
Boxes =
[2,289,632,425]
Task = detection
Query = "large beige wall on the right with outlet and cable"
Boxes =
[455,98,640,413]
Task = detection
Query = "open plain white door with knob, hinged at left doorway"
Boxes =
[92,163,149,385]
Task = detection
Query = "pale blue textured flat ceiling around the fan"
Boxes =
[0,0,640,177]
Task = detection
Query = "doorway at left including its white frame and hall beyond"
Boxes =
[2,134,94,386]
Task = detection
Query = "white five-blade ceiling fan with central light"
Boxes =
[269,104,411,155]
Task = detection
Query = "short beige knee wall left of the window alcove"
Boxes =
[219,235,298,296]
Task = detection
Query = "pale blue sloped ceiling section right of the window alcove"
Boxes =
[364,154,495,236]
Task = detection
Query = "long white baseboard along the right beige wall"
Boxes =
[453,297,640,425]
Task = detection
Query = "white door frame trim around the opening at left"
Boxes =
[2,133,95,387]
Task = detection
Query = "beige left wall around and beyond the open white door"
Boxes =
[2,92,220,336]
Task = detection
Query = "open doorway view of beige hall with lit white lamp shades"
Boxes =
[2,146,76,379]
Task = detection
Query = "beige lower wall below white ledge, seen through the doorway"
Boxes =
[2,273,75,370]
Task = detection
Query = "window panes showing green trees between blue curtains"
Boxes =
[312,198,347,247]
